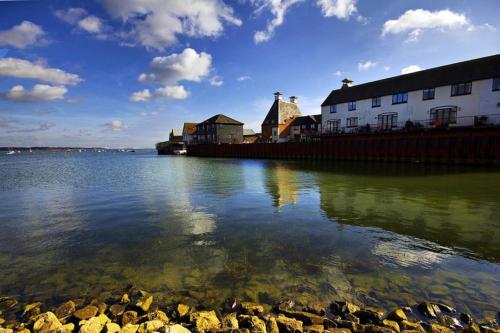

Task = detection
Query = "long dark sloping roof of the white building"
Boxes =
[321,54,500,106]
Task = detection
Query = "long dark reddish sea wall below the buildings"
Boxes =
[187,127,500,165]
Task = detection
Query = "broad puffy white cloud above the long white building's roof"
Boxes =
[382,9,471,42]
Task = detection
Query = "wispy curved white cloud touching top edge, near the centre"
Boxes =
[252,0,303,44]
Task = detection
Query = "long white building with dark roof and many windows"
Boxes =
[321,54,500,134]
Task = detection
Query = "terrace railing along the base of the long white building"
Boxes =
[322,114,500,135]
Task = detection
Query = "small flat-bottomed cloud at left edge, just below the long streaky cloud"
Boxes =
[2,84,68,103]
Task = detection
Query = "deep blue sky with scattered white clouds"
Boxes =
[0,0,500,148]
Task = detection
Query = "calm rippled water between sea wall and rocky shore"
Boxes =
[0,152,500,317]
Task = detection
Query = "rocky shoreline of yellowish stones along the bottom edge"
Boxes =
[0,287,500,333]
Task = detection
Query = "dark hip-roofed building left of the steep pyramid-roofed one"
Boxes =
[195,114,243,143]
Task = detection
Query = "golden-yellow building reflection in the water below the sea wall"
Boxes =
[265,163,299,208]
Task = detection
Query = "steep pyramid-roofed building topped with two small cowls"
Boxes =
[262,92,300,142]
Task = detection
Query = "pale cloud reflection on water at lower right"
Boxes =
[372,237,451,268]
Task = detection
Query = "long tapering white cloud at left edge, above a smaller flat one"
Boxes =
[0,58,82,85]
